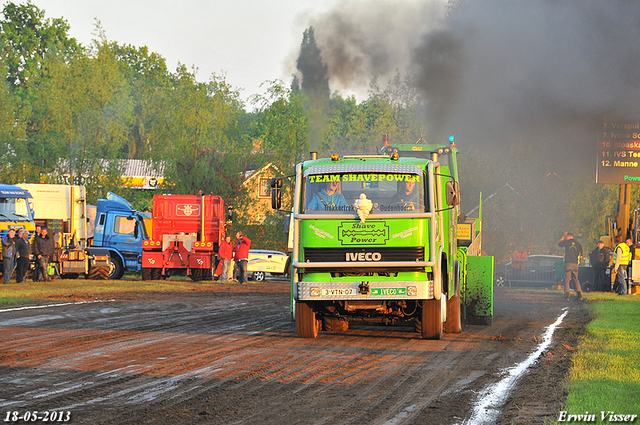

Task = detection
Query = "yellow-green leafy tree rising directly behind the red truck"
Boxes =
[147,66,251,202]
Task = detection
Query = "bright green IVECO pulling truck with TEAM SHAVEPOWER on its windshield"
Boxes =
[271,139,493,339]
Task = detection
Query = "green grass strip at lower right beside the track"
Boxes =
[558,293,640,423]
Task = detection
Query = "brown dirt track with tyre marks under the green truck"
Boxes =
[0,282,588,424]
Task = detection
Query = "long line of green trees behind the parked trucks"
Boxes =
[0,2,620,257]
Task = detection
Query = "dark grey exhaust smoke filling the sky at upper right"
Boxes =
[302,0,640,169]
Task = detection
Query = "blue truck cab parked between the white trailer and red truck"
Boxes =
[93,192,149,279]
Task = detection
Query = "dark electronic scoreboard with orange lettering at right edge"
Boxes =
[596,120,640,184]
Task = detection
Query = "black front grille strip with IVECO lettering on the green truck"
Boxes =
[304,246,425,273]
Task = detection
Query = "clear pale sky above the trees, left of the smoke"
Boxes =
[28,0,338,100]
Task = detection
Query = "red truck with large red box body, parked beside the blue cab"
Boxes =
[142,195,225,281]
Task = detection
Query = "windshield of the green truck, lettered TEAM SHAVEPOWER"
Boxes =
[303,173,425,213]
